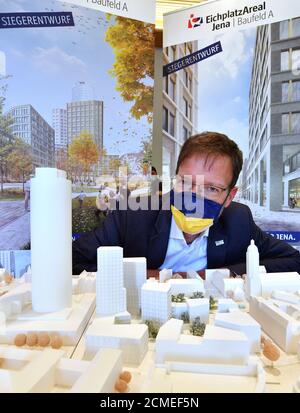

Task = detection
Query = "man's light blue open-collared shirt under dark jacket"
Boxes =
[160,217,209,272]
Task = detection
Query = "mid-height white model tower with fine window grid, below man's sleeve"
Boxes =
[96,247,127,316]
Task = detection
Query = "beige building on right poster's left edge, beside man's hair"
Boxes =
[163,41,198,177]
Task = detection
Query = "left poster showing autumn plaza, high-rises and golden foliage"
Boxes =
[0,0,155,272]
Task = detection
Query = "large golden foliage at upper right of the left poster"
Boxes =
[105,16,154,123]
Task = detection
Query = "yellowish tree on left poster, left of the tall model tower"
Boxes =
[7,138,33,192]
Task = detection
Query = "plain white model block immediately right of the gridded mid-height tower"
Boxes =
[123,258,147,317]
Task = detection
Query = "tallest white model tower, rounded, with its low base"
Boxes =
[0,168,95,345]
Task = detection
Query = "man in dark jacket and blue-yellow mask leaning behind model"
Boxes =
[73,132,300,275]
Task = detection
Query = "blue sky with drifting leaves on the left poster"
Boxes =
[0,0,151,155]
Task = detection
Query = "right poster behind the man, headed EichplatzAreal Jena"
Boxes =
[163,0,300,249]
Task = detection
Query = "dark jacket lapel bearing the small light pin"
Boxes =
[207,223,227,268]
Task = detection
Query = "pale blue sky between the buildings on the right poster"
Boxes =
[198,28,256,158]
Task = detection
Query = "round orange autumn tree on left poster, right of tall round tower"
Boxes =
[68,131,100,178]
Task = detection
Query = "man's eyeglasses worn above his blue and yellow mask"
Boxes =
[172,176,230,200]
